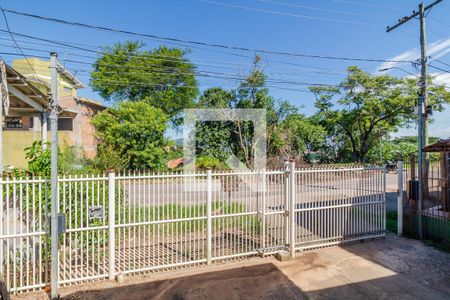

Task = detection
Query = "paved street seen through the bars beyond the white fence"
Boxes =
[124,174,397,211]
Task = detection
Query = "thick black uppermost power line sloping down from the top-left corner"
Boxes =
[0,9,413,63]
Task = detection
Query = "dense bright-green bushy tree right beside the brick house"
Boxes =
[92,101,168,170]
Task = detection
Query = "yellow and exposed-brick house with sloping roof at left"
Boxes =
[1,58,105,168]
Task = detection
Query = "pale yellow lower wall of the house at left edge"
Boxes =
[3,130,69,169]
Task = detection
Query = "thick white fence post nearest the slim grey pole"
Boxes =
[108,170,116,279]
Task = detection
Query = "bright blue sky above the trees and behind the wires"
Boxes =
[0,0,450,137]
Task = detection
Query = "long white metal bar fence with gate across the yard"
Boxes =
[0,167,385,291]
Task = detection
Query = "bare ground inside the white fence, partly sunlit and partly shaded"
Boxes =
[13,234,450,299]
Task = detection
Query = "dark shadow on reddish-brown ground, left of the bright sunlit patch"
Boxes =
[61,263,306,300]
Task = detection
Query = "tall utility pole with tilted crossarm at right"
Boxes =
[386,0,443,239]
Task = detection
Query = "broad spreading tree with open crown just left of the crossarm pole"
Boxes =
[311,66,450,163]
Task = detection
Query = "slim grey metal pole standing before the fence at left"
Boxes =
[49,52,59,299]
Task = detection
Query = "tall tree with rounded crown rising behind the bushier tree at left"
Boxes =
[91,41,198,124]
